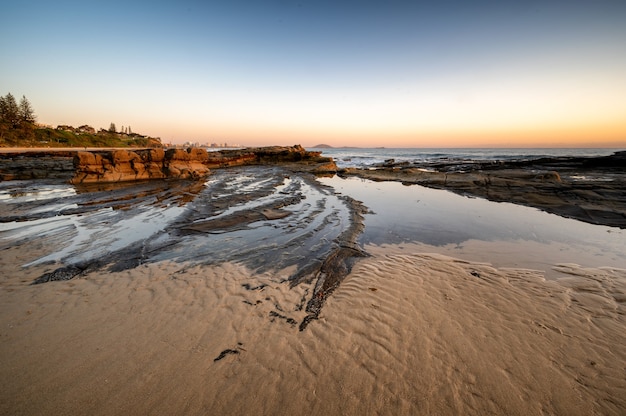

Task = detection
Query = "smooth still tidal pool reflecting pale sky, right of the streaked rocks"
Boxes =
[320,177,626,268]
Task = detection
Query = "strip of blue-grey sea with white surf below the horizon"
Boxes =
[307,147,624,168]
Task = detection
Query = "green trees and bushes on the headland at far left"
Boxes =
[0,93,162,147]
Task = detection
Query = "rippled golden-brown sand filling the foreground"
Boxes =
[0,242,626,415]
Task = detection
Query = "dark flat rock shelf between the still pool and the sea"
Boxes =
[339,152,626,228]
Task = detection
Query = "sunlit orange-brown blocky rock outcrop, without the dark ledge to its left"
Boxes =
[71,145,337,184]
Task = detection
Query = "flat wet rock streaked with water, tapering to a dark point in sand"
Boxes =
[0,166,365,329]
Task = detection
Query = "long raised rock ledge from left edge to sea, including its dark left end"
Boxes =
[0,145,337,184]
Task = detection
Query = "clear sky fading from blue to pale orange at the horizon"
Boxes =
[0,0,626,148]
